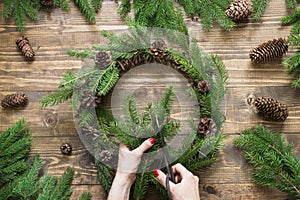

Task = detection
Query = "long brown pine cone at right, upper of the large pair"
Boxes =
[249,38,288,62]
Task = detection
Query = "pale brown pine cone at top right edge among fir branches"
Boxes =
[225,0,253,21]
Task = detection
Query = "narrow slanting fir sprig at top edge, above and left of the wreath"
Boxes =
[73,0,96,23]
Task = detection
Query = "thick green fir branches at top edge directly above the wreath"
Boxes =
[119,0,188,35]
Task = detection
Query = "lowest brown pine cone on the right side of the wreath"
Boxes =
[198,117,218,137]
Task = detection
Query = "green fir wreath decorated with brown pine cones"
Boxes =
[40,25,227,199]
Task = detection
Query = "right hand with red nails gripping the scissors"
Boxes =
[154,163,200,200]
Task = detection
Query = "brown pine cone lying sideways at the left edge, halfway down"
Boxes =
[1,94,28,108]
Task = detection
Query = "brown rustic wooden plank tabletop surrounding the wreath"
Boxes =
[0,0,300,200]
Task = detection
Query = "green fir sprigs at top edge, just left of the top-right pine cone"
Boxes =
[178,0,235,31]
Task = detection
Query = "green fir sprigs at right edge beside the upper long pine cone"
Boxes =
[281,8,300,88]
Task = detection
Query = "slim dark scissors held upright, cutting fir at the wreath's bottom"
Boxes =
[155,115,175,200]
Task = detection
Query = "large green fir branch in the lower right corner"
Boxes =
[234,125,300,199]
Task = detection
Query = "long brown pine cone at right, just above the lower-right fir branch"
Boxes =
[247,95,289,121]
